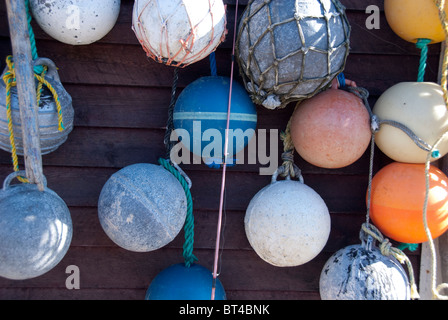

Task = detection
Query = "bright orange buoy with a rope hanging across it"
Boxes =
[370,162,448,243]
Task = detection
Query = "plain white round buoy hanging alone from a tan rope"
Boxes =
[244,179,331,267]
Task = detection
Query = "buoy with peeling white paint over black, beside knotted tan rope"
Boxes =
[319,235,411,300]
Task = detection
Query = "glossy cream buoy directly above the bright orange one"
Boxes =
[372,82,448,163]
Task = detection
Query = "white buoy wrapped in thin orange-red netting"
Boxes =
[132,0,226,66]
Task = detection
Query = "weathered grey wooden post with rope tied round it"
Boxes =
[6,0,44,191]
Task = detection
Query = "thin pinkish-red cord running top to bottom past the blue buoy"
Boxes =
[211,0,238,300]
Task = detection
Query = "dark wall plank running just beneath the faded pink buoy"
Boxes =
[0,165,367,213]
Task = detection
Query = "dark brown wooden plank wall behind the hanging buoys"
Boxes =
[0,0,440,300]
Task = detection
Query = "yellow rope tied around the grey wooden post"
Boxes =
[3,55,64,183]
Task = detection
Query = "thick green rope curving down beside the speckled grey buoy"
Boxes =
[159,158,198,268]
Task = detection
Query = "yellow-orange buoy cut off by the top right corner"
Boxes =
[384,0,448,43]
